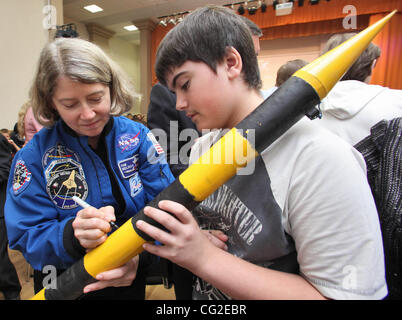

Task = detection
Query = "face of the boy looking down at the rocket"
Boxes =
[166,61,237,131]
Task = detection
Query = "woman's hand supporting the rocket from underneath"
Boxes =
[84,255,139,293]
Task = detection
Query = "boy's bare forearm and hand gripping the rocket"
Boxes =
[137,201,324,299]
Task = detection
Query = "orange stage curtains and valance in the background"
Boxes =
[151,0,402,89]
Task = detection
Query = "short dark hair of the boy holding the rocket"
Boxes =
[155,5,261,89]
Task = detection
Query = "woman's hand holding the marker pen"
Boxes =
[72,206,116,249]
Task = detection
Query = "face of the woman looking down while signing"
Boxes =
[52,76,111,141]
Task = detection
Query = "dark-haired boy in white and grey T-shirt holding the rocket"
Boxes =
[137,6,387,299]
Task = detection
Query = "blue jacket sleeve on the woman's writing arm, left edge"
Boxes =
[5,146,74,270]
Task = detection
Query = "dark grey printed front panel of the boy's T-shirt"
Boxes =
[193,157,297,300]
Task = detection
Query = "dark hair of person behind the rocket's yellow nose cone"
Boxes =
[322,33,381,82]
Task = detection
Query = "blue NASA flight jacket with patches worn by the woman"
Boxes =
[5,117,174,270]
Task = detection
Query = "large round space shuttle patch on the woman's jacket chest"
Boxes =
[46,170,88,209]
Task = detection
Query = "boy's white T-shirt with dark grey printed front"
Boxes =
[190,119,387,299]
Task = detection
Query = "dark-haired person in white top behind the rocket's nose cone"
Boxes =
[317,33,402,145]
